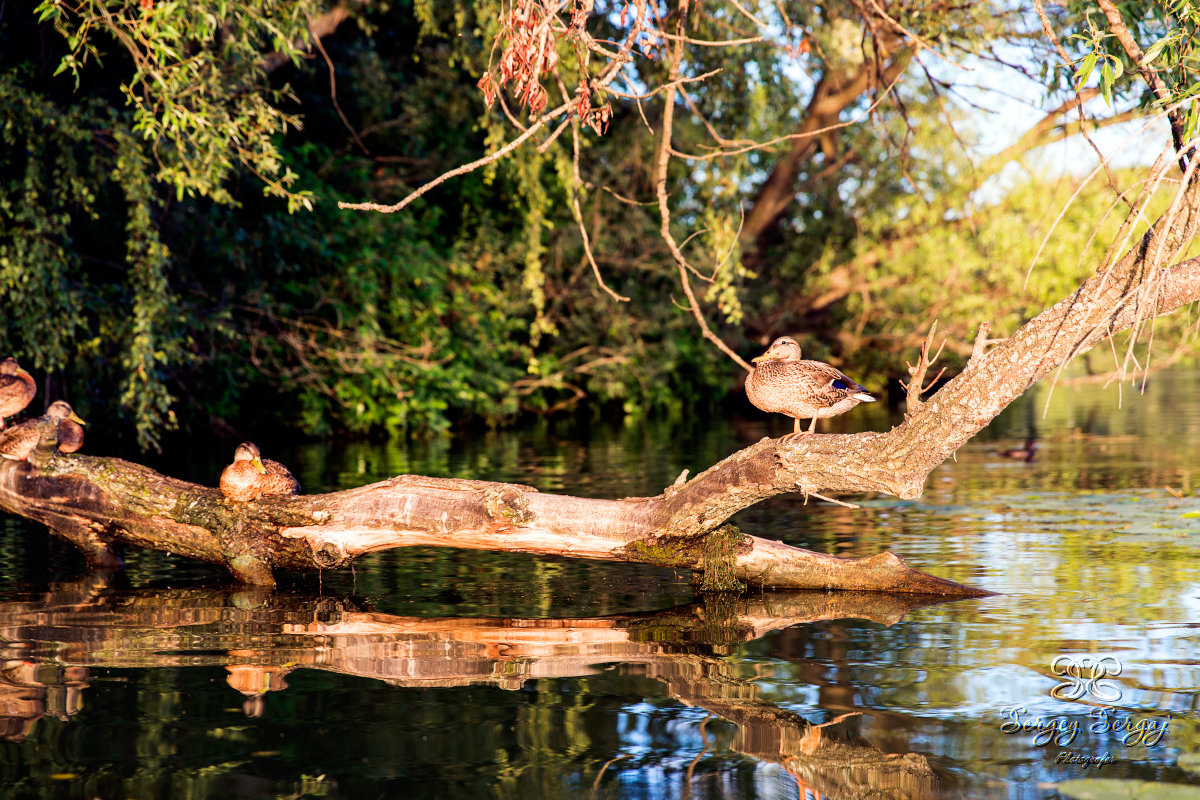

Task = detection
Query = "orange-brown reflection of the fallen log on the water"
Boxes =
[0,573,944,798]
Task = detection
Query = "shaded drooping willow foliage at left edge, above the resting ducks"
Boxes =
[0,73,185,447]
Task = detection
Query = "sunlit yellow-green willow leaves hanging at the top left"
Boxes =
[36,0,328,211]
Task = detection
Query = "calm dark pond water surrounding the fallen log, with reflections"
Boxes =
[0,373,1200,800]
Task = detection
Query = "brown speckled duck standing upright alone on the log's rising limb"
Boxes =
[746,336,875,438]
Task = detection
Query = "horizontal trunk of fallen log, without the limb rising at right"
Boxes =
[0,438,986,596]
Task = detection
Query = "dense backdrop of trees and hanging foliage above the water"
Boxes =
[0,0,1198,447]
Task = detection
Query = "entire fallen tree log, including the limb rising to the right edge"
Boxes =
[0,206,1200,596]
